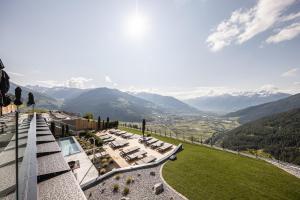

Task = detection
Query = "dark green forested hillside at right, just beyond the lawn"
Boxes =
[223,109,300,165]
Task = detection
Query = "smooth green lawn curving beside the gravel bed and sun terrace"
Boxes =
[121,128,300,200]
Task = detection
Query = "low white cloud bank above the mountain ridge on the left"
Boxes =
[37,77,93,88]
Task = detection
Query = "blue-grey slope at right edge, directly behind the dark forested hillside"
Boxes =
[226,94,300,123]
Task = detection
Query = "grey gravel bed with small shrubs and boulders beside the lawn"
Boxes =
[84,166,183,200]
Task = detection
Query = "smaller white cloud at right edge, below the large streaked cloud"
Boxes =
[266,23,300,43]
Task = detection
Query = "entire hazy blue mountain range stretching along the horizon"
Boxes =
[15,84,300,123]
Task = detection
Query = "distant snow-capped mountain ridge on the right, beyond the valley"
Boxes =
[185,91,290,114]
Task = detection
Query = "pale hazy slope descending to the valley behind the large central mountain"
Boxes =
[135,92,200,114]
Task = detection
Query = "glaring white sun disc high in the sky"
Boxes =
[126,13,149,39]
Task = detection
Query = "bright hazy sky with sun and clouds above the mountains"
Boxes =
[0,0,300,99]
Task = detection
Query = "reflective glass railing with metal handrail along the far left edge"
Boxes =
[0,113,36,199]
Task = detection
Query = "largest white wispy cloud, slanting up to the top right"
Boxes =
[206,0,296,52]
